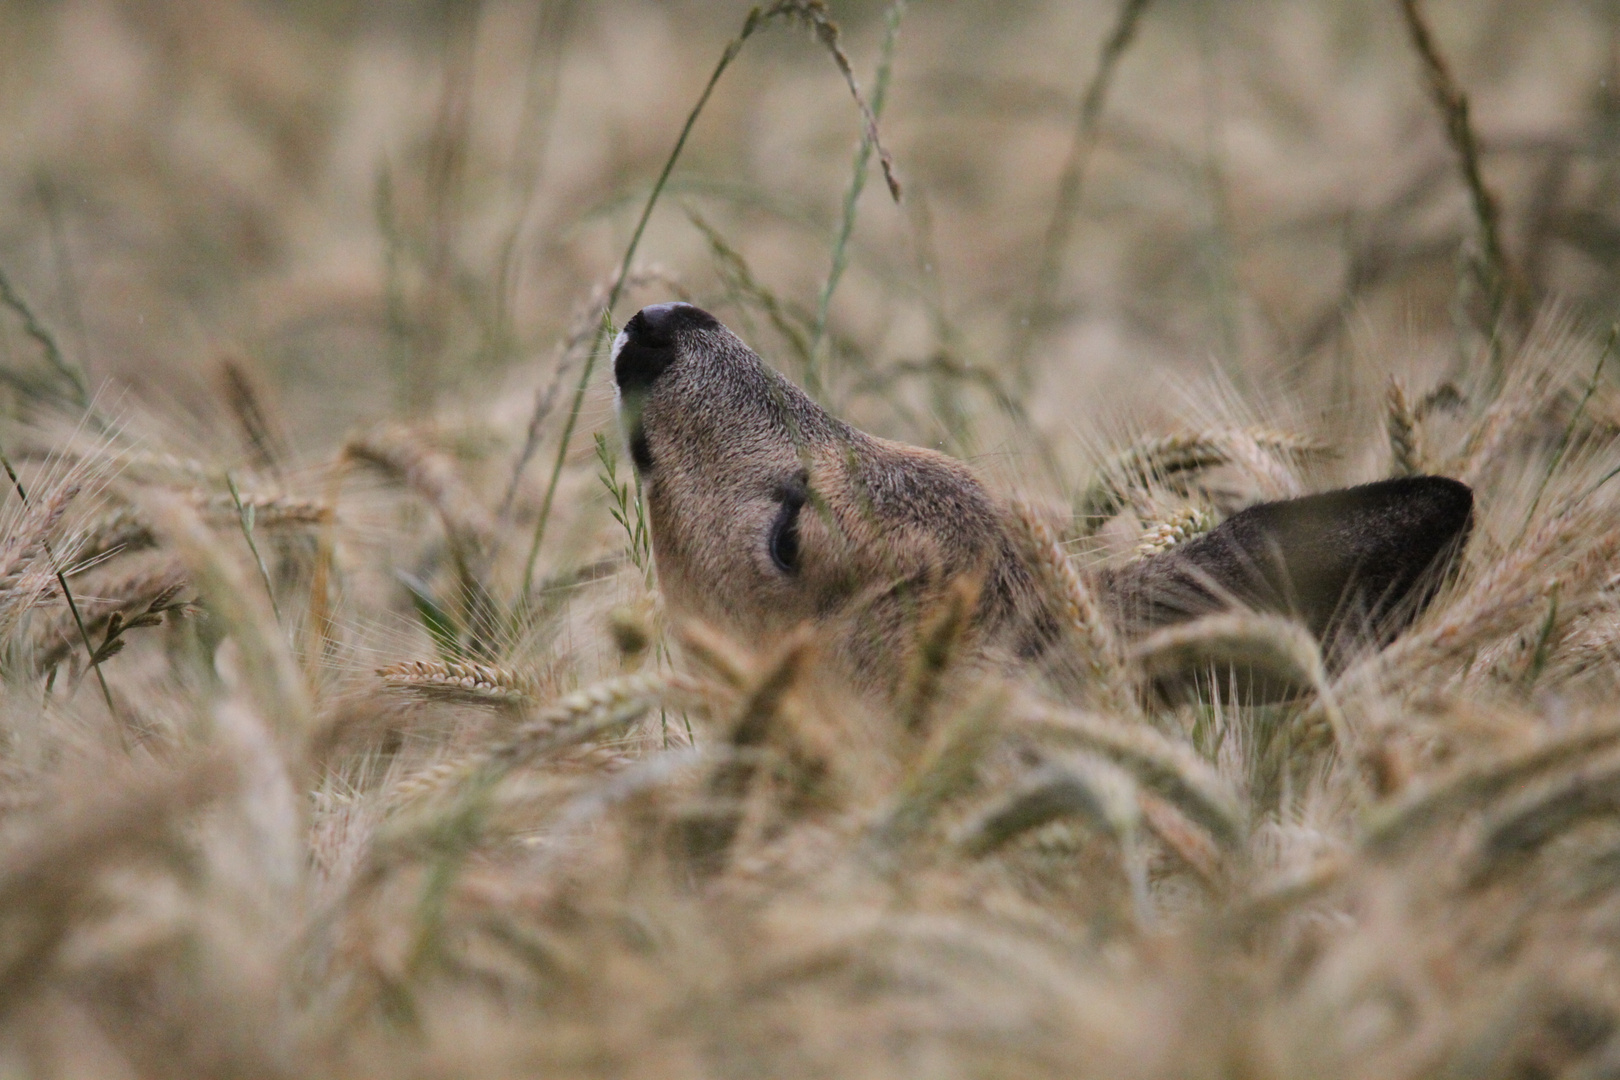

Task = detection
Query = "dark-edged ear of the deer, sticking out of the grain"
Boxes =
[1115,476,1474,651]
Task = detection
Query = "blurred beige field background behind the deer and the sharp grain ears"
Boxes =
[0,0,1620,485]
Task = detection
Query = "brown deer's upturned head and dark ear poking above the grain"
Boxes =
[614,304,1471,687]
